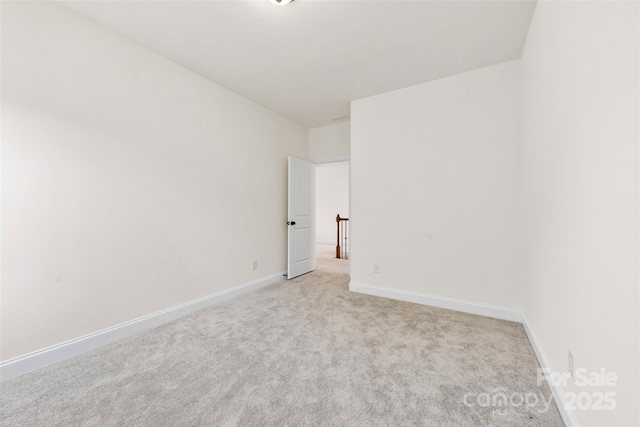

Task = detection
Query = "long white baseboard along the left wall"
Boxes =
[0,272,284,381]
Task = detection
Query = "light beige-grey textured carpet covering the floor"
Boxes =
[0,249,563,426]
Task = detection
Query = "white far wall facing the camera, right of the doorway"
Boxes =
[351,61,522,308]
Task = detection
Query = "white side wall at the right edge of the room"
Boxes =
[522,1,640,426]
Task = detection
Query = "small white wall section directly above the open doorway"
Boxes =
[309,122,351,163]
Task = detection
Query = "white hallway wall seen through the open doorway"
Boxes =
[316,162,349,246]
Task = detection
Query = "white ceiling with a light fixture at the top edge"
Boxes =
[60,0,535,127]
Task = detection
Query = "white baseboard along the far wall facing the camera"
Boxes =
[349,282,522,322]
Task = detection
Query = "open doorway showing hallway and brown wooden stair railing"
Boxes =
[316,161,351,274]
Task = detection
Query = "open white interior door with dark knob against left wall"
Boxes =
[287,157,316,279]
